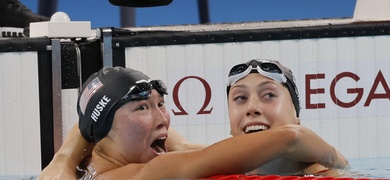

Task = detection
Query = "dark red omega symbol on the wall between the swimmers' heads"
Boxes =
[172,76,213,116]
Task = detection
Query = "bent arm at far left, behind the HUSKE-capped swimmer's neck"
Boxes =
[38,123,93,179]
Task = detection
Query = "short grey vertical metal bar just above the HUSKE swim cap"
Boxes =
[101,28,113,67]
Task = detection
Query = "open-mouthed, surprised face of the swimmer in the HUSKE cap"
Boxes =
[108,89,170,163]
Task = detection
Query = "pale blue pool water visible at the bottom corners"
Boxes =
[0,157,390,180]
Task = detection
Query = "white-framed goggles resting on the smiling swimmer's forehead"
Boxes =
[227,60,287,87]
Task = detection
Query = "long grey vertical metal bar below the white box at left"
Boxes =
[51,39,62,152]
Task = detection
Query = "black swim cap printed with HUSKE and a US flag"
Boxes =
[77,67,149,143]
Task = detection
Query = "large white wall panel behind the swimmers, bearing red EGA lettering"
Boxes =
[126,36,390,158]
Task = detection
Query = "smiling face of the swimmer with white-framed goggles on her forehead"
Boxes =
[228,73,299,136]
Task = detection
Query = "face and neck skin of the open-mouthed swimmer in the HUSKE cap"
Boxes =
[91,90,170,174]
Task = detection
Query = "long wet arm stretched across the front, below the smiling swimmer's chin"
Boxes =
[135,125,348,179]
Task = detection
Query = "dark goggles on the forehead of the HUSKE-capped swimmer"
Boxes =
[121,79,168,103]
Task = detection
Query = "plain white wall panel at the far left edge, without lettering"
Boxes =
[0,52,41,176]
